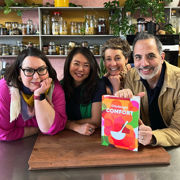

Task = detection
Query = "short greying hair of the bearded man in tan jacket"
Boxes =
[133,32,163,54]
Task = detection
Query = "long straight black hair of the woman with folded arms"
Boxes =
[62,47,100,104]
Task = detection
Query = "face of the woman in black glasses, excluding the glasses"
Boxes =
[20,56,49,92]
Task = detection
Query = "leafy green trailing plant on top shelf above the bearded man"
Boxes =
[104,0,171,35]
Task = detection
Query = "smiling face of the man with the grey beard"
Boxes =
[134,39,165,82]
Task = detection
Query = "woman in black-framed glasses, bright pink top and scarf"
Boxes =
[0,48,67,141]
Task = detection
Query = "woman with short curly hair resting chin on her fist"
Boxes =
[102,37,131,95]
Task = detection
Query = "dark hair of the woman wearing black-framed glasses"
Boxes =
[4,47,57,89]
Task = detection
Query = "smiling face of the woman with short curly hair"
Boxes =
[104,49,128,76]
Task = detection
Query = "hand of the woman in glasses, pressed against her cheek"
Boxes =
[34,78,52,96]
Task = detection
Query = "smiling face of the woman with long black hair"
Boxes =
[69,53,90,86]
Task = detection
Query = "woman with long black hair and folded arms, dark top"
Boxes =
[61,47,105,135]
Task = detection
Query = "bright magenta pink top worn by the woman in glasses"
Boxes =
[0,79,67,141]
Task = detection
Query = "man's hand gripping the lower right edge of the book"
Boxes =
[138,119,152,146]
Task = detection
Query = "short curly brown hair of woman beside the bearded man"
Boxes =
[102,37,131,59]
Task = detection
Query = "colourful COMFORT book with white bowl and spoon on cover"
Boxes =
[101,95,140,151]
